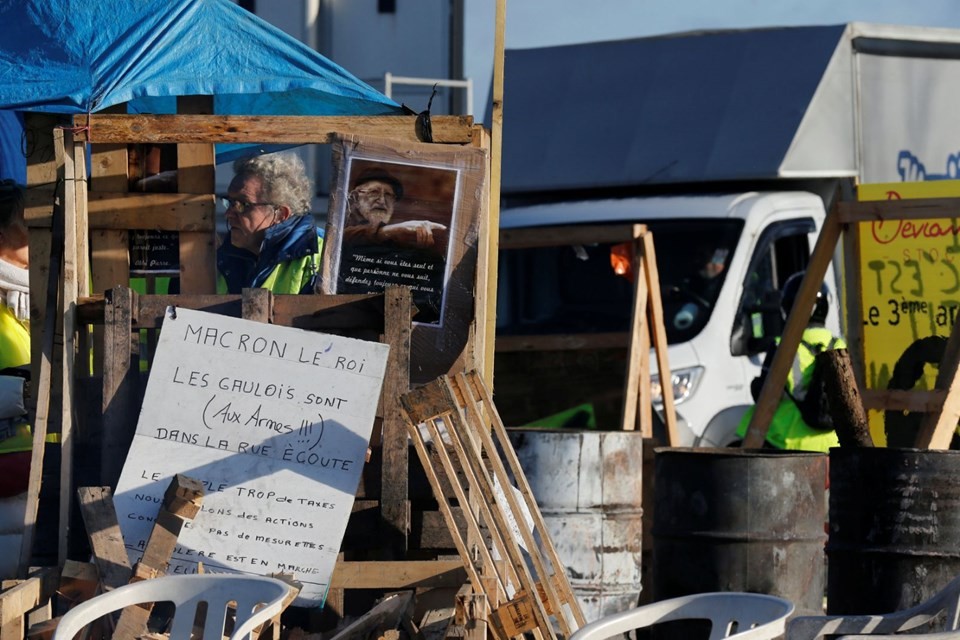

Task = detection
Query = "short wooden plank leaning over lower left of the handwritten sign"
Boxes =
[113,474,203,640]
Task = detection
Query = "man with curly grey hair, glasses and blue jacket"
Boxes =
[217,153,323,293]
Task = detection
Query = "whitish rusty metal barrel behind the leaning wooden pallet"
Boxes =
[508,428,643,620]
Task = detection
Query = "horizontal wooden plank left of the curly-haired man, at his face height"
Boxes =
[88,194,216,231]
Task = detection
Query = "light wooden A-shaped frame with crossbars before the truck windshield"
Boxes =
[497,224,679,445]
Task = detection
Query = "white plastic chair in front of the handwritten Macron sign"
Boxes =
[53,574,293,640]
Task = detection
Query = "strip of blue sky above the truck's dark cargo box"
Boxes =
[464,0,960,121]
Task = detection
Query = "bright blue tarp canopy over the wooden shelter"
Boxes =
[0,0,402,180]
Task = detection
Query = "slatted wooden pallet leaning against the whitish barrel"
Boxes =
[401,372,584,639]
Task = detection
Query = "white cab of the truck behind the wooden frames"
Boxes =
[494,191,839,446]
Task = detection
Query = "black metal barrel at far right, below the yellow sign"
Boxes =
[827,447,960,615]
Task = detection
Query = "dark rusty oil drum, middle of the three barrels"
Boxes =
[653,448,827,615]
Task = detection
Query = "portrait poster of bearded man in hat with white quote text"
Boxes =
[322,137,487,380]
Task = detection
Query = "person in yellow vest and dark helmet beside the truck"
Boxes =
[737,272,847,453]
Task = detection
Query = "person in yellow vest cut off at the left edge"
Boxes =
[0,180,33,500]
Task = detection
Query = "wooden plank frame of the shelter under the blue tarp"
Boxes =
[21,112,497,628]
